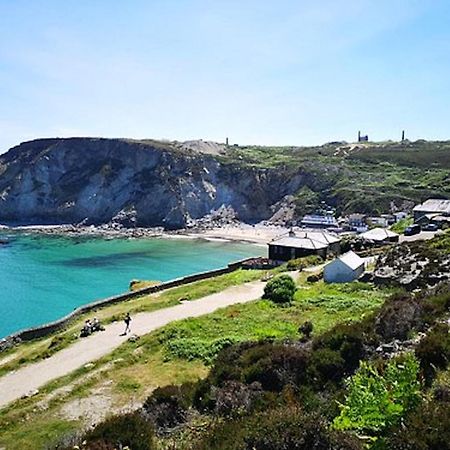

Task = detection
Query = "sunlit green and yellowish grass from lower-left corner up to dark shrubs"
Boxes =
[0,272,389,450]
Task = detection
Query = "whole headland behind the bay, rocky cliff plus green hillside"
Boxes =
[0,138,450,228]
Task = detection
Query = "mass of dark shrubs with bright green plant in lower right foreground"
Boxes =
[59,283,450,450]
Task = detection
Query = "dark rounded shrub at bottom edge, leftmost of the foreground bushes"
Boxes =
[83,412,155,450]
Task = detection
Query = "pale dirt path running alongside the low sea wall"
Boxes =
[0,281,264,408]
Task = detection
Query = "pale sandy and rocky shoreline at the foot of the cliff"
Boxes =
[0,224,289,246]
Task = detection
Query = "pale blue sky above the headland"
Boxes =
[0,0,450,152]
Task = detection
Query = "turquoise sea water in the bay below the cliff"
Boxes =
[0,234,265,337]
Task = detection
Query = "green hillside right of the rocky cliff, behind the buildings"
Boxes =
[221,141,450,214]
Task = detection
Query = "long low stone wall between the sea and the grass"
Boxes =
[0,258,254,344]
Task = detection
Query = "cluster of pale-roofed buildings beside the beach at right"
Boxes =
[269,195,450,282]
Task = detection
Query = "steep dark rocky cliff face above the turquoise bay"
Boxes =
[0,138,308,228]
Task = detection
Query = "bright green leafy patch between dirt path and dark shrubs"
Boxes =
[156,282,385,364]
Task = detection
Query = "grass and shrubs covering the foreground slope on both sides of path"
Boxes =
[0,234,450,450]
